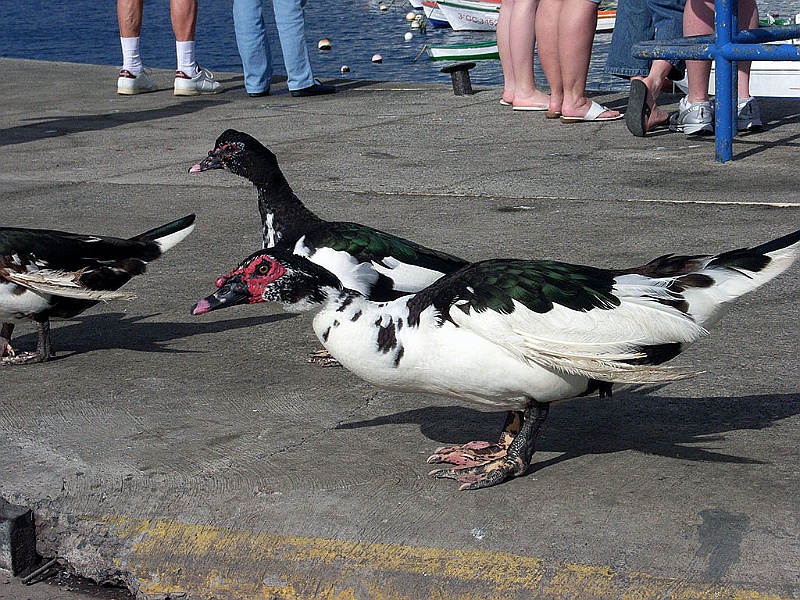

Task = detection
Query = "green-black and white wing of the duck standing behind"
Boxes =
[303,222,467,293]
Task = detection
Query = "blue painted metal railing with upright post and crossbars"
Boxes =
[633,0,800,163]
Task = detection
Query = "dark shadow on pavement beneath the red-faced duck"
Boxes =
[339,388,800,469]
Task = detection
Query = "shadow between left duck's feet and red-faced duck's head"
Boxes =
[14,312,296,358]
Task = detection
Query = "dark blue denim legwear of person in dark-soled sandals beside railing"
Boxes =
[605,0,686,79]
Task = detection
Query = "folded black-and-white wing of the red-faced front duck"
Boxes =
[409,260,703,382]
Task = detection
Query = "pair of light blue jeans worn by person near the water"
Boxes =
[233,0,314,94]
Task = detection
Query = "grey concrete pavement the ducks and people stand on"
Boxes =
[0,59,800,600]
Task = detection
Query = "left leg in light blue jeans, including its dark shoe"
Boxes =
[233,0,272,94]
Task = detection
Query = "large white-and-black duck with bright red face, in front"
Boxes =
[192,231,800,489]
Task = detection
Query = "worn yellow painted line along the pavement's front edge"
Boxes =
[82,517,784,600]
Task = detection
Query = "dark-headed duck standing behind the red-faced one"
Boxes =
[189,129,467,301]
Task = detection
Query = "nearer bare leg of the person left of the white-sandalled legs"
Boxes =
[509,0,550,108]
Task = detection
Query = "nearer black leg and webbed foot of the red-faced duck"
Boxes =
[429,400,550,490]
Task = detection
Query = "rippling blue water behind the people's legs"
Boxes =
[0,0,800,90]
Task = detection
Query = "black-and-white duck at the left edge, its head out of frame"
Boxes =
[0,215,195,364]
